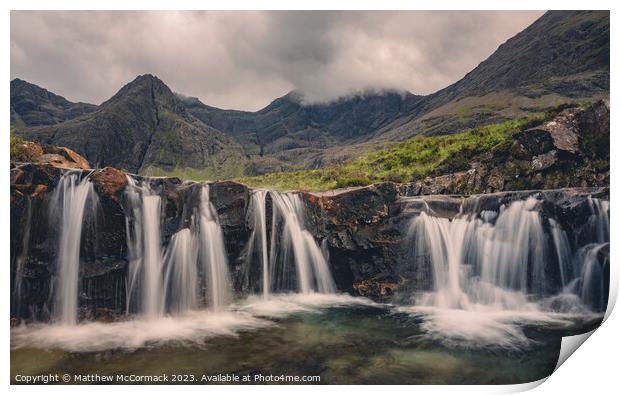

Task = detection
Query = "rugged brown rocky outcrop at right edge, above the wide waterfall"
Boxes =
[401,101,610,196]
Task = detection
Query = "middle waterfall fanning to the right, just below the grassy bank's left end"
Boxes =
[269,192,336,294]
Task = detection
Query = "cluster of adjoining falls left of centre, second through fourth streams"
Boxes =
[126,182,232,318]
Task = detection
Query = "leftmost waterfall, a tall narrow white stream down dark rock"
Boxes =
[52,171,93,325]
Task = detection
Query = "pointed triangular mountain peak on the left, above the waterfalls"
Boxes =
[16,74,245,176]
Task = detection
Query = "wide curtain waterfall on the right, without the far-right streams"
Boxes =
[409,199,546,309]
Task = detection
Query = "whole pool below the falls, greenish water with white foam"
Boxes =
[11,296,600,384]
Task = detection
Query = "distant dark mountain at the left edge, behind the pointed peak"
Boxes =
[11,78,97,127]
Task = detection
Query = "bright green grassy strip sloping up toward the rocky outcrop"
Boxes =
[237,111,557,191]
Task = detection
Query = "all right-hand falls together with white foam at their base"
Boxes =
[403,198,609,347]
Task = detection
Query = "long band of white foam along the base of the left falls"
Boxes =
[11,293,378,352]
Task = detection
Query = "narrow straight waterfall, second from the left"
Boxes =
[126,175,164,318]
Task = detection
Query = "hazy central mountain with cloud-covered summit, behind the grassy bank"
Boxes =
[182,91,422,172]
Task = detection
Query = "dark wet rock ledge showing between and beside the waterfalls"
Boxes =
[11,159,609,319]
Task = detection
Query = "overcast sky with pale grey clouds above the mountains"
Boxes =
[11,11,543,110]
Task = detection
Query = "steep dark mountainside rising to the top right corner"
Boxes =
[377,11,610,140]
